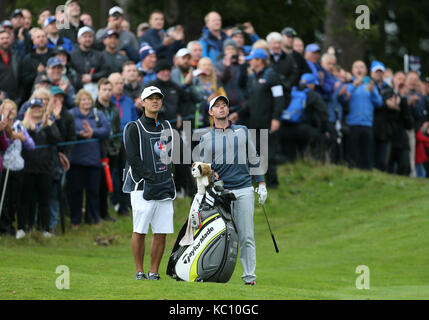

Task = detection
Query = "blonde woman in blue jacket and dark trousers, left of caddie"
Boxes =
[68,89,110,230]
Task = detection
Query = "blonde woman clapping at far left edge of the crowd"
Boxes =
[0,99,35,239]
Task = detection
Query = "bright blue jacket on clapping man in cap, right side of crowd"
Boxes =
[346,83,383,127]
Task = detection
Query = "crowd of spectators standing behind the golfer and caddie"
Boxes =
[0,0,429,239]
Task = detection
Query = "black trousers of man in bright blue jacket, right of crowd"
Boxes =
[346,126,374,170]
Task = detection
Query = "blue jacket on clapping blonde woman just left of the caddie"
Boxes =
[70,107,110,167]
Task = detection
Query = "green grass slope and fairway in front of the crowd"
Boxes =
[0,163,429,300]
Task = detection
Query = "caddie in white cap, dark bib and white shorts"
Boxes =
[123,86,176,280]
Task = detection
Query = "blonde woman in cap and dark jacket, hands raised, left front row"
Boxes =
[17,98,61,238]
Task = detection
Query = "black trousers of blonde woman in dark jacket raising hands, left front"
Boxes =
[18,172,52,231]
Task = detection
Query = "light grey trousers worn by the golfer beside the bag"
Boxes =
[231,187,256,283]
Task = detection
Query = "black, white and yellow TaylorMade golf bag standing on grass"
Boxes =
[167,183,238,283]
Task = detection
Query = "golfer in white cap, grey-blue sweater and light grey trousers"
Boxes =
[200,96,267,286]
